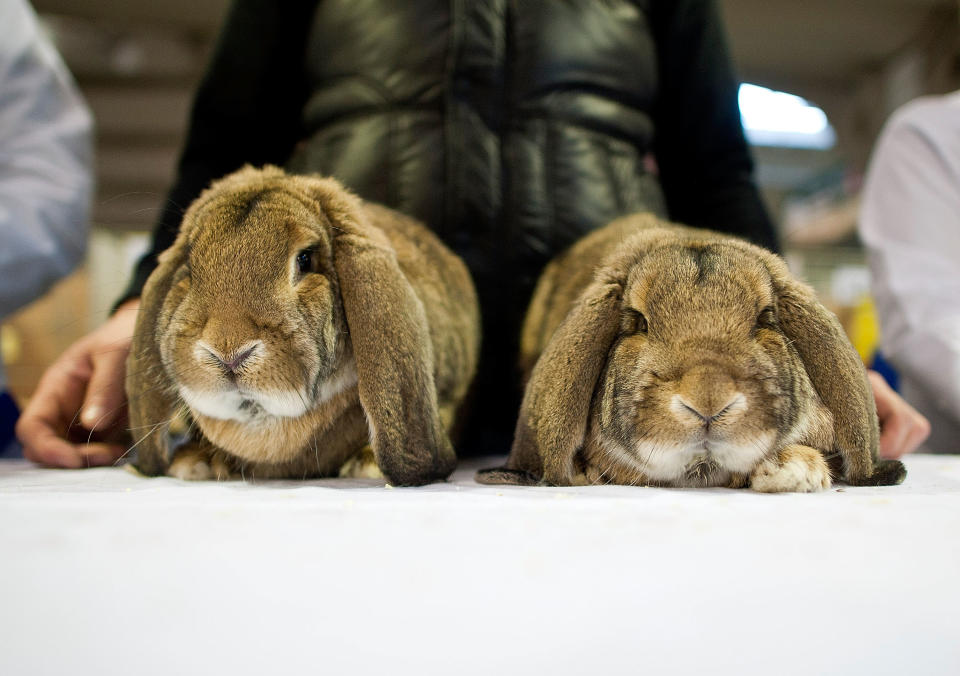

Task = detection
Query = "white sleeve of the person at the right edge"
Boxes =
[860,94,960,421]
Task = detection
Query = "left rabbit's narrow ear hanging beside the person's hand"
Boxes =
[126,234,188,476]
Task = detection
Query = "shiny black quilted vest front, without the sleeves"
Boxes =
[289,0,665,316]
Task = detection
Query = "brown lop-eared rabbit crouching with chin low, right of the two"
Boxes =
[477,214,906,492]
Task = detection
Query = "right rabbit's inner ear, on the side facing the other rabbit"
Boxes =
[506,277,623,486]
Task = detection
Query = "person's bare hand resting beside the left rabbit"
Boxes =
[16,299,140,468]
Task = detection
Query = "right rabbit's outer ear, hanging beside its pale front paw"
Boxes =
[764,252,906,485]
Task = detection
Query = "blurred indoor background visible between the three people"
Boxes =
[0,0,960,402]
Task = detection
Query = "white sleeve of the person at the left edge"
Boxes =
[0,0,93,319]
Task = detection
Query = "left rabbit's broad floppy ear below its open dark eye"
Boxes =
[307,178,456,485]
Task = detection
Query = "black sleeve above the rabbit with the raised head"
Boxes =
[117,0,316,305]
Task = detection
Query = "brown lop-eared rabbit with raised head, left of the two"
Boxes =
[127,167,480,485]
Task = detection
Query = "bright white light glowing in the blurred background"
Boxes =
[739,84,837,150]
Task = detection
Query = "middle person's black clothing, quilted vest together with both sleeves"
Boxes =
[128,0,775,453]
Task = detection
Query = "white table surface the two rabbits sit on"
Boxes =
[0,456,960,676]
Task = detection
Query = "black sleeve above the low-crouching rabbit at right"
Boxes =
[652,0,779,251]
